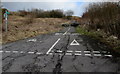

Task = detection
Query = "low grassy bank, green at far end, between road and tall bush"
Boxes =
[76,26,120,54]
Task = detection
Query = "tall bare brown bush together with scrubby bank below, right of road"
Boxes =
[81,2,120,52]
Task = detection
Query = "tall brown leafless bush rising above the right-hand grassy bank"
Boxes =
[82,2,120,38]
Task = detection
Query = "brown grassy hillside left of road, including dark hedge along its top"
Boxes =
[0,9,73,43]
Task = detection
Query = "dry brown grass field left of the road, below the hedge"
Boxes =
[2,15,67,44]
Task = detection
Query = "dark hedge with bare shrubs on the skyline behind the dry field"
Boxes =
[16,9,73,19]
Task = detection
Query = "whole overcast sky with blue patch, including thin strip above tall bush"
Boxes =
[2,0,119,16]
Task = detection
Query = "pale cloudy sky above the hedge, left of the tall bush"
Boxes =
[2,2,89,16]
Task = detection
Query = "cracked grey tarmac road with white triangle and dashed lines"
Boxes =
[0,27,120,72]
